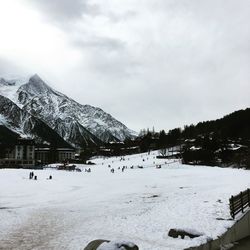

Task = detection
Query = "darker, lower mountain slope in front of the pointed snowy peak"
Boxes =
[0,95,69,146]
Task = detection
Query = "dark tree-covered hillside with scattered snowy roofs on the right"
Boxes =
[134,108,250,168]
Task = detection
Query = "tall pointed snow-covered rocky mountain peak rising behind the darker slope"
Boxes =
[0,75,136,146]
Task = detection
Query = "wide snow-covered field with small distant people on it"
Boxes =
[0,152,250,250]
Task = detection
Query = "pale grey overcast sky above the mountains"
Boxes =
[0,0,250,131]
